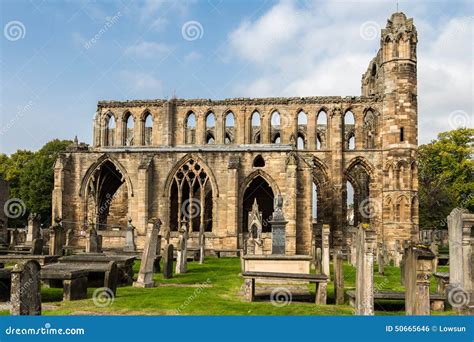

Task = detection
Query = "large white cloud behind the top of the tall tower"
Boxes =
[228,1,473,143]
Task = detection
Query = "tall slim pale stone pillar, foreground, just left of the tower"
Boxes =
[355,223,377,316]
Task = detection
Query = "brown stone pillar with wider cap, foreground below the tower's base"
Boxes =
[405,245,434,316]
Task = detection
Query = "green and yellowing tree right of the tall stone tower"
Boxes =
[418,128,474,228]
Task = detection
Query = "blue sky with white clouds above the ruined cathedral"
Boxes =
[0,0,474,154]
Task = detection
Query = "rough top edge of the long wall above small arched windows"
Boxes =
[97,96,380,109]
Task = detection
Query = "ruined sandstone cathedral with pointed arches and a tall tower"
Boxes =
[53,13,418,255]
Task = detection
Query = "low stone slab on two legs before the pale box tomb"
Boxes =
[242,272,328,304]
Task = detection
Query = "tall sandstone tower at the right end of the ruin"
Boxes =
[362,12,418,246]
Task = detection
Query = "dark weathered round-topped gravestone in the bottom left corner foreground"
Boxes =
[10,260,41,315]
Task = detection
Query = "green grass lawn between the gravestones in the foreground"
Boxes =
[0,257,453,315]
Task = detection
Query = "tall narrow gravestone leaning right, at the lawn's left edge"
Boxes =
[133,219,161,287]
